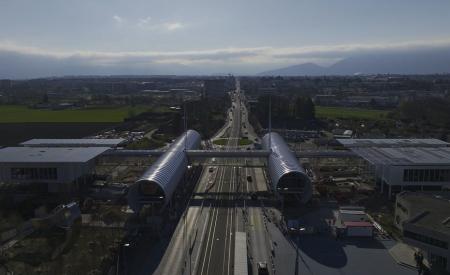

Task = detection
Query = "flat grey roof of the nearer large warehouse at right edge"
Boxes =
[351,147,450,166]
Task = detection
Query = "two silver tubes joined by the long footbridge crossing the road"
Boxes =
[125,130,355,212]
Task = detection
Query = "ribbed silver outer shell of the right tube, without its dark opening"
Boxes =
[262,132,312,201]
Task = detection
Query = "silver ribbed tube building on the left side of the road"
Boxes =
[128,130,201,212]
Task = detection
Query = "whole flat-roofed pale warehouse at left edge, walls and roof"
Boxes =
[0,147,110,190]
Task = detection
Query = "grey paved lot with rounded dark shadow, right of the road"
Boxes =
[268,203,417,275]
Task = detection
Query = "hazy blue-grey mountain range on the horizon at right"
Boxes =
[258,49,450,76]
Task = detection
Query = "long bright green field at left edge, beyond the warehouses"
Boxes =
[0,105,155,123]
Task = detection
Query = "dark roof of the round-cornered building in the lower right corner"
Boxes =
[397,192,450,234]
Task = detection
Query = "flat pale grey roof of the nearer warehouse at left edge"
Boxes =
[0,147,110,163]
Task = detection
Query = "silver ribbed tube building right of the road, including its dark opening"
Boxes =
[262,132,312,203]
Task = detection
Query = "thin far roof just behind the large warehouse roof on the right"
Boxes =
[337,138,450,148]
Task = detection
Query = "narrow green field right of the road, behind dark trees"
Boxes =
[316,106,389,120]
